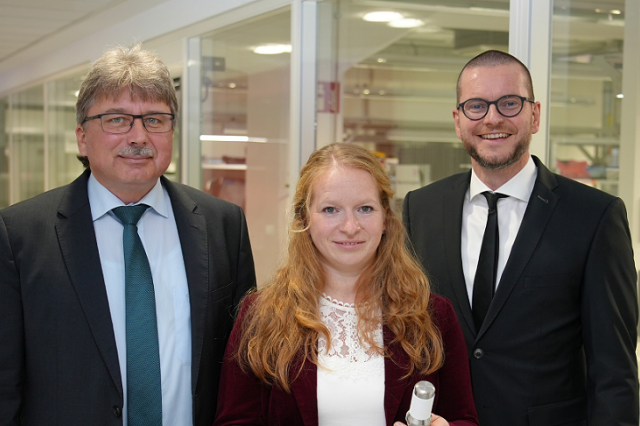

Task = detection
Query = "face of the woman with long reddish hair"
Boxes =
[308,166,385,278]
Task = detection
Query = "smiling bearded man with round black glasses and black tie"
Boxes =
[403,51,638,426]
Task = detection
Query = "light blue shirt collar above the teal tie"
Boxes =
[87,174,169,221]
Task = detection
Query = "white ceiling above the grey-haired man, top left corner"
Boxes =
[0,0,182,84]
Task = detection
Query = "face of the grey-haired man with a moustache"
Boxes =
[76,89,173,204]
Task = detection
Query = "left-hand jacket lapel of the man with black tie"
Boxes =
[441,172,475,330]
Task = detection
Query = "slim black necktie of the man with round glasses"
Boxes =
[473,191,508,331]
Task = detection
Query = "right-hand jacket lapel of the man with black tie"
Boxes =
[476,157,558,339]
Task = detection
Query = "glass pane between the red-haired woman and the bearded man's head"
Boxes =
[318,0,509,210]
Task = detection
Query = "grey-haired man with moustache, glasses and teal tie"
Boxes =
[0,45,255,426]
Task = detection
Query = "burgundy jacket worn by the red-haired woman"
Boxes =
[215,294,478,426]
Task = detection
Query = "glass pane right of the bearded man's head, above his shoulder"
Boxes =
[549,0,625,195]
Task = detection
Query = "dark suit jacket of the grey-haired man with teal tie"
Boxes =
[0,172,255,426]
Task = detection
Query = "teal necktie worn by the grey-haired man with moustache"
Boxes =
[113,204,162,426]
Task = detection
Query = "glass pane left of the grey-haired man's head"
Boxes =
[0,74,82,207]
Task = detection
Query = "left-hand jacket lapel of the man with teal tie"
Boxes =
[56,171,123,395]
